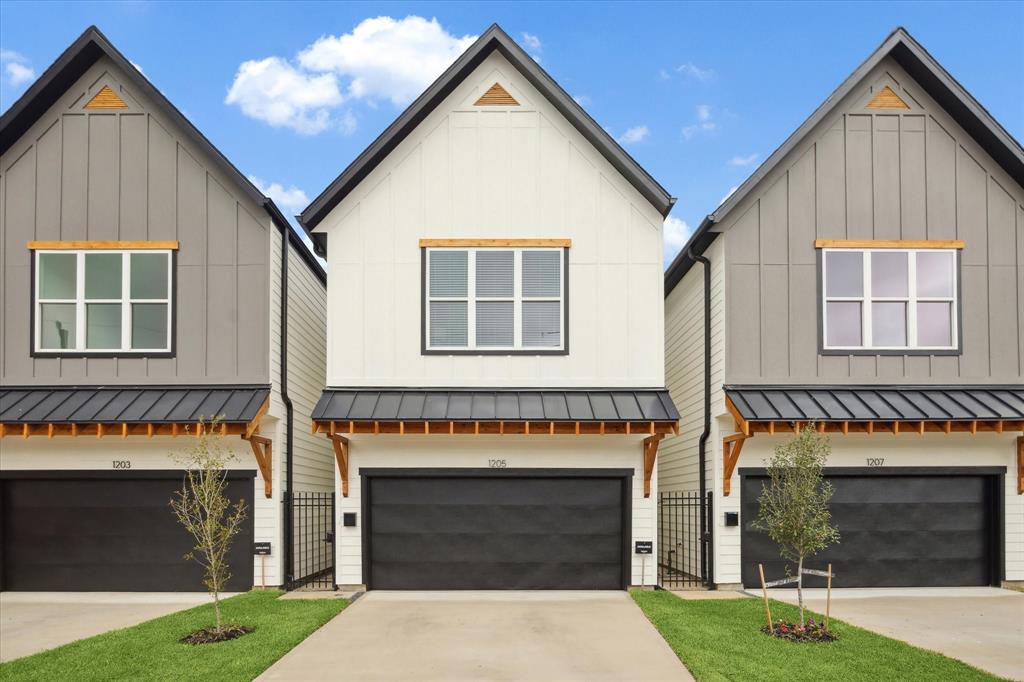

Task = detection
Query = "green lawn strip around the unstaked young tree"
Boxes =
[0,591,348,682]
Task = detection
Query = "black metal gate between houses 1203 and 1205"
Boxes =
[286,491,338,590]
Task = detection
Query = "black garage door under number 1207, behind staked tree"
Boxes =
[740,469,998,587]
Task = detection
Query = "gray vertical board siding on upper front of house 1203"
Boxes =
[0,58,275,385]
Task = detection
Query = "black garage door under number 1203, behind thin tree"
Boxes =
[0,472,253,592]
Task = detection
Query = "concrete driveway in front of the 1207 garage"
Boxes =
[770,588,1024,680]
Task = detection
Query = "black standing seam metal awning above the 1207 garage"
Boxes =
[725,384,1024,422]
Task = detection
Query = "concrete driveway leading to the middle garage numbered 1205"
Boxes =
[257,592,693,682]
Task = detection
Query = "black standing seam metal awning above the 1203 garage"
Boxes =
[0,385,270,424]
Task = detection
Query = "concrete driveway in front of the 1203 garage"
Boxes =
[0,592,221,660]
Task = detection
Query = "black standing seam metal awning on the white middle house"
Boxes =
[312,388,679,422]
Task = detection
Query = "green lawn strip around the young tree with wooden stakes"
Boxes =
[633,591,999,682]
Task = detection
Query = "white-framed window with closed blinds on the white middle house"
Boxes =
[424,247,567,353]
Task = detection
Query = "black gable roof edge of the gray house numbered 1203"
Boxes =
[0,26,327,283]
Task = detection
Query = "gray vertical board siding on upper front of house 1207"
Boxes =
[722,54,1024,383]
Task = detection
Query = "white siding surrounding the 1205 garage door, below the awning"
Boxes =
[337,435,657,585]
